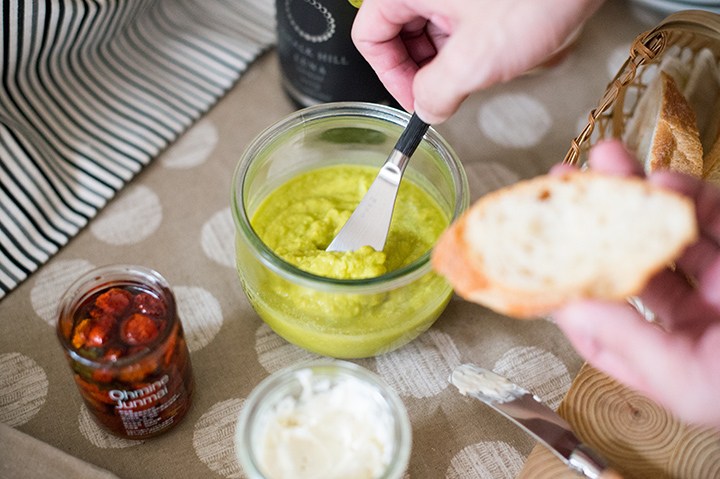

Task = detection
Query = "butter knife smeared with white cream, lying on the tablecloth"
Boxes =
[450,364,621,479]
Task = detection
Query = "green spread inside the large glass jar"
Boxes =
[245,165,452,358]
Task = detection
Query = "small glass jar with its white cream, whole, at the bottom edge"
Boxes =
[235,360,412,479]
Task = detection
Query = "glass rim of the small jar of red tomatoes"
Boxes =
[55,264,179,368]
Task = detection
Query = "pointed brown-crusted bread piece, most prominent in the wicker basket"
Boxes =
[626,71,703,177]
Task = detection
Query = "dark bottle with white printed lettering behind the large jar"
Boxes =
[275,0,394,106]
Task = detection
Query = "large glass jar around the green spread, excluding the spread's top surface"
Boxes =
[232,102,469,358]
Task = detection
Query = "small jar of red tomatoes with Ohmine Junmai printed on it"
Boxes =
[57,265,193,439]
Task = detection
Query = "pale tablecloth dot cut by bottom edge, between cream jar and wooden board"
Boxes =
[445,441,524,479]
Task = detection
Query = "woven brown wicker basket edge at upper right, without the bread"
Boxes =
[564,10,720,164]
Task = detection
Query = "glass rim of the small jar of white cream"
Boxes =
[235,359,412,479]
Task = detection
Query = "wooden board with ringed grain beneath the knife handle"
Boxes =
[518,364,720,479]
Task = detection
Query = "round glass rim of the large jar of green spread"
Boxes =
[231,101,469,293]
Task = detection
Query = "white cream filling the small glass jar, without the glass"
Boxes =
[254,370,395,479]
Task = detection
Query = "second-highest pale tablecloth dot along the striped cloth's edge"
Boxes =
[90,185,162,246]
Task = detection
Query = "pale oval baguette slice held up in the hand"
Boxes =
[432,171,698,318]
